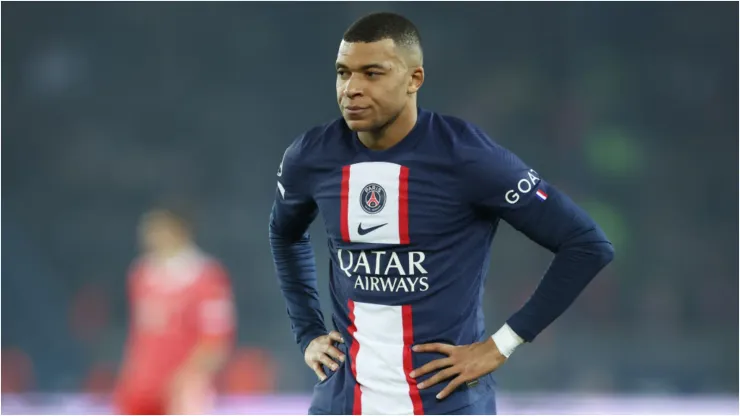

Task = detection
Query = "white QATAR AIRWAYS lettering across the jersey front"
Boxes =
[337,249,429,293]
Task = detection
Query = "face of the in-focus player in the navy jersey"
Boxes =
[336,39,415,131]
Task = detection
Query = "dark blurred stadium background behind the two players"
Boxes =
[2,2,739,413]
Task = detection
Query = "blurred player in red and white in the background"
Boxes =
[115,207,235,414]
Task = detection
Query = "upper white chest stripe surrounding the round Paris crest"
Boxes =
[347,162,401,244]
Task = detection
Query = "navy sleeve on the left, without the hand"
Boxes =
[270,138,328,353]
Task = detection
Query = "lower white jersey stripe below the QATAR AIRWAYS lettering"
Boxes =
[354,302,414,415]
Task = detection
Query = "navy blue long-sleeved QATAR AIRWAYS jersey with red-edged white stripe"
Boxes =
[270,110,612,414]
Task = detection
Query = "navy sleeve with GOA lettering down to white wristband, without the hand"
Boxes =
[465,131,614,356]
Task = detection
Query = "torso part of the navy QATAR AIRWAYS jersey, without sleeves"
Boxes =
[298,109,495,413]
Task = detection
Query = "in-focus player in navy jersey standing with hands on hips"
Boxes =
[270,13,614,414]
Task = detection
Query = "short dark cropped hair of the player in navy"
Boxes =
[342,12,421,52]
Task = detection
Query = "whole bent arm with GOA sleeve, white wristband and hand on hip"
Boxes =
[410,131,614,399]
